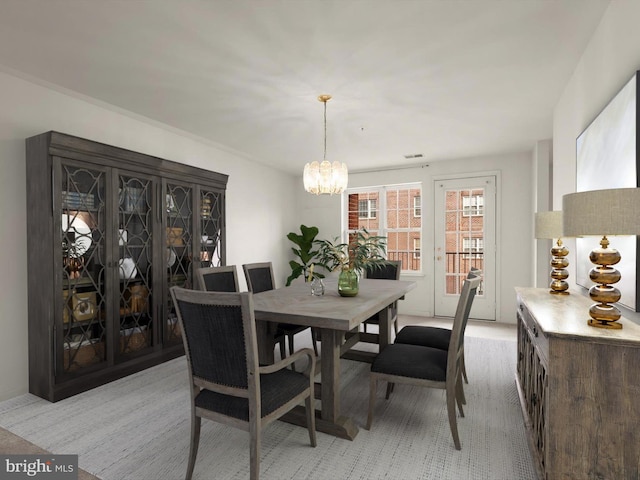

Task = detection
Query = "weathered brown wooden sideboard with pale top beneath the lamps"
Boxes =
[516,288,640,480]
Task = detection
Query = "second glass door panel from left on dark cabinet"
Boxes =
[115,174,154,357]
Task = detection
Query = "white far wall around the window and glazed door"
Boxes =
[297,153,534,323]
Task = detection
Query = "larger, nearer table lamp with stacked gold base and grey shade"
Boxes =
[562,188,640,329]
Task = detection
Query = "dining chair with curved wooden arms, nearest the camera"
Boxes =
[171,286,316,480]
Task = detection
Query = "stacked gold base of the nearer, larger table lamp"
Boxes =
[587,235,622,330]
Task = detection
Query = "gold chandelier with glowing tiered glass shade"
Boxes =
[302,95,349,195]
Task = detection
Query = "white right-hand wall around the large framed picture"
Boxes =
[553,0,640,322]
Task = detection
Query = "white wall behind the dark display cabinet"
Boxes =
[0,73,299,400]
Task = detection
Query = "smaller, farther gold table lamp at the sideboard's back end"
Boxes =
[535,210,569,295]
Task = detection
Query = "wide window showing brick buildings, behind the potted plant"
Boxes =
[343,183,422,272]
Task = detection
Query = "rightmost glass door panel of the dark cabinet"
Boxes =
[199,190,225,267]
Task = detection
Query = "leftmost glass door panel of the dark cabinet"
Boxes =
[54,158,107,375]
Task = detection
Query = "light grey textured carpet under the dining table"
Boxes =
[0,337,536,480]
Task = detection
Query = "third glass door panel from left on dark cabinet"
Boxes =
[163,182,194,345]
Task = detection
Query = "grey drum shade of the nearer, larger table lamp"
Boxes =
[562,188,640,237]
